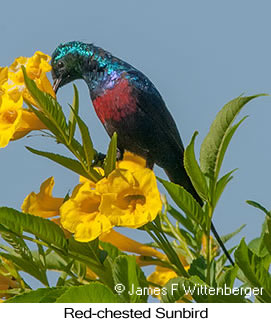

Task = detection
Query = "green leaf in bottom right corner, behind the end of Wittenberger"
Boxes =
[234,239,271,303]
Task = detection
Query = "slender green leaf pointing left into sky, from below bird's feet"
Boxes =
[26,146,102,182]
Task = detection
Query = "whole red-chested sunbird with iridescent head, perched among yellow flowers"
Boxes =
[51,41,234,265]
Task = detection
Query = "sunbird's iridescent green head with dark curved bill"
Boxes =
[51,41,93,92]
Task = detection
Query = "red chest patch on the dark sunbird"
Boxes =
[93,79,136,123]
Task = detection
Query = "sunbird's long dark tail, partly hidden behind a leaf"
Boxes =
[165,163,234,266]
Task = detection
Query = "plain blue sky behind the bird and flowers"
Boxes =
[0,0,271,286]
